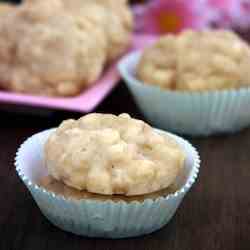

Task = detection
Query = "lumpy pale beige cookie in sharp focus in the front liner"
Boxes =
[45,114,185,196]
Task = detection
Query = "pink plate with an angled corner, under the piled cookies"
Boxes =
[0,35,154,113]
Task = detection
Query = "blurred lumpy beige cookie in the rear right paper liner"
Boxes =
[137,30,250,91]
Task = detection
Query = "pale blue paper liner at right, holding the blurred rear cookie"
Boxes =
[119,52,250,136]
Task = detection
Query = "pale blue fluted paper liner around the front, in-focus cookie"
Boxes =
[15,130,200,238]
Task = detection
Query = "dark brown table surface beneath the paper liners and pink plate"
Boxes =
[0,84,250,250]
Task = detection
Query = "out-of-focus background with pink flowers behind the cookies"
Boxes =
[4,0,250,43]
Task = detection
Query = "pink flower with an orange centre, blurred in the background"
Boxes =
[135,0,209,34]
